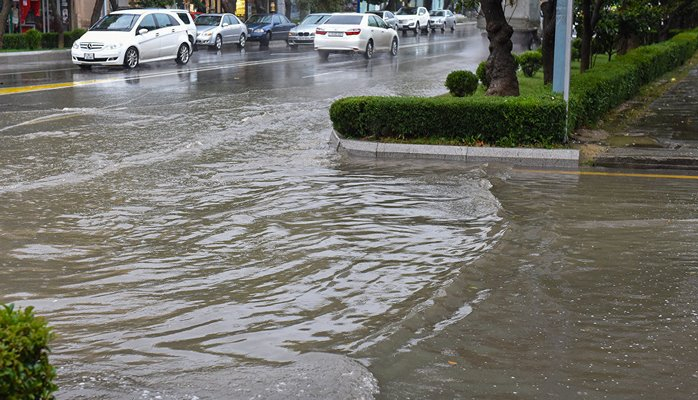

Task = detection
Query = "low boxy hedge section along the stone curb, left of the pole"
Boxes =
[330,96,565,147]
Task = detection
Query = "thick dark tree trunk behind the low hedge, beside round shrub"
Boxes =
[480,0,519,96]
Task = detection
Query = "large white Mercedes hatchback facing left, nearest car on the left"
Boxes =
[71,9,192,68]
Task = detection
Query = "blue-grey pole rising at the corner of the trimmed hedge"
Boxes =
[553,0,573,101]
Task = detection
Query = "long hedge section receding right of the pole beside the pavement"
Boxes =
[570,32,698,128]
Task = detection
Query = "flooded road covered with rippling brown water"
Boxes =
[0,28,698,399]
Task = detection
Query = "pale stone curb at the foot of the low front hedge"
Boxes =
[330,130,579,168]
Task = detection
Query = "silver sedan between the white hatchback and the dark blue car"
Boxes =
[195,14,247,50]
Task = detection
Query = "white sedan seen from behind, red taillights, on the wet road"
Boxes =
[314,13,399,60]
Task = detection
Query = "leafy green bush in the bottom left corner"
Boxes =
[0,304,57,399]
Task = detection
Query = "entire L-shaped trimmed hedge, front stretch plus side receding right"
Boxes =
[330,31,698,146]
